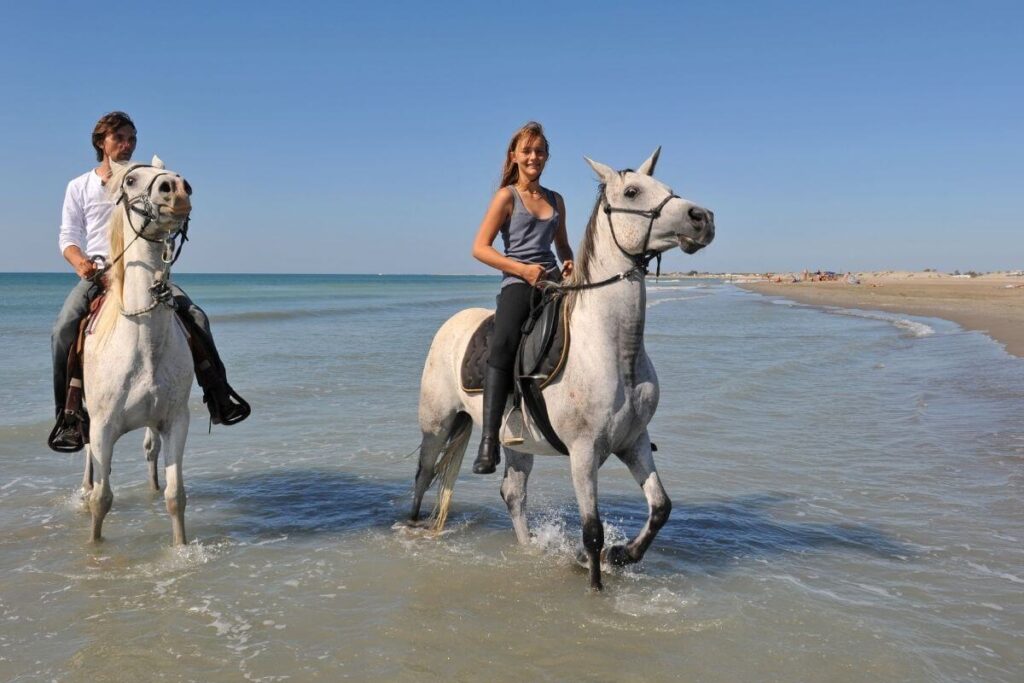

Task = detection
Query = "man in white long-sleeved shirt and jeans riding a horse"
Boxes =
[49,112,249,452]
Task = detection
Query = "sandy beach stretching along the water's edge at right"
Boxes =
[739,270,1024,357]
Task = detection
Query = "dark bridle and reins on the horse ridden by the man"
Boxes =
[104,164,190,317]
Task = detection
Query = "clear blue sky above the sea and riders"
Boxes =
[0,0,1024,273]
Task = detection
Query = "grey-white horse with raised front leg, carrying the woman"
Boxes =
[411,148,715,590]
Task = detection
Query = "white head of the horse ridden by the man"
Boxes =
[108,156,191,242]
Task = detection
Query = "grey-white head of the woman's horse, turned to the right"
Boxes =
[584,147,715,260]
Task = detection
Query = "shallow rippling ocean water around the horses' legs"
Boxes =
[0,274,1024,683]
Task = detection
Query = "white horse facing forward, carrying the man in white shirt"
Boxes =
[83,157,193,544]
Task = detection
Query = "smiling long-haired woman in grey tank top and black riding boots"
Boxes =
[473,121,572,474]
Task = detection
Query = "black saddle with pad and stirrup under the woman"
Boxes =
[461,294,569,455]
